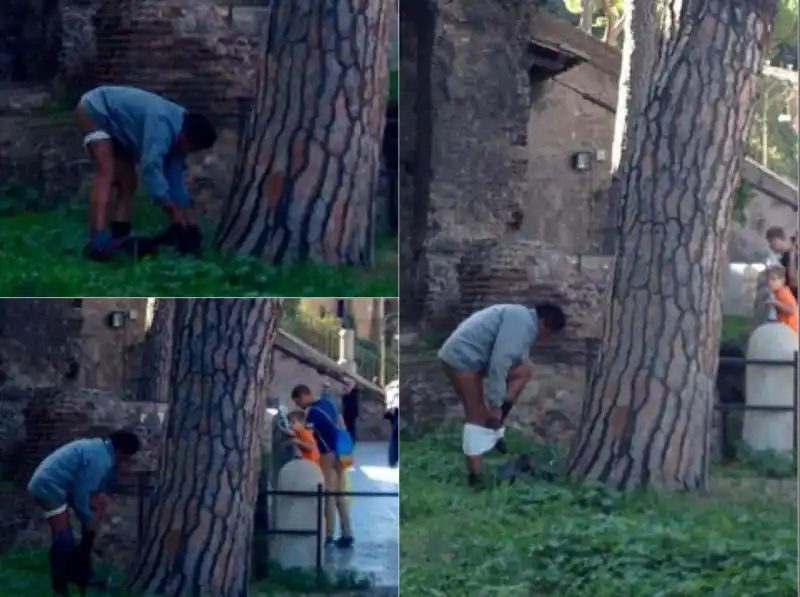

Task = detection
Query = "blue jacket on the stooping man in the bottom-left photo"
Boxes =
[28,438,116,524]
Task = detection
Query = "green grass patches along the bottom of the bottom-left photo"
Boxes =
[0,549,369,597]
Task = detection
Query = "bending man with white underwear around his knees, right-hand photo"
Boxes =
[439,303,566,485]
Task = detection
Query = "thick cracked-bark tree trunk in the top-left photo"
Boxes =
[218,0,396,266]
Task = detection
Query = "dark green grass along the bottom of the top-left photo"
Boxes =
[0,200,397,297]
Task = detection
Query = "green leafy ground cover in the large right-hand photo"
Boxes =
[400,434,797,597]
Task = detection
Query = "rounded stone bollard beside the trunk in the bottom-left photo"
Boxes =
[272,459,323,569]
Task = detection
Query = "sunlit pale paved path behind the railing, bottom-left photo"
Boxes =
[325,442,400,587]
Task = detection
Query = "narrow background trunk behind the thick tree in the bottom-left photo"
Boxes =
[138,299,175,403]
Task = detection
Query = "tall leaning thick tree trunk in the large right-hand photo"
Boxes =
[569,0,776,489]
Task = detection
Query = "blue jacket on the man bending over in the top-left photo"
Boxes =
[81,85,190,206]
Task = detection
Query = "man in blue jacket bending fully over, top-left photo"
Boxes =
[76,86,217,261]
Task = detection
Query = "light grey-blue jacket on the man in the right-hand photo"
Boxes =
[439,305,539,406]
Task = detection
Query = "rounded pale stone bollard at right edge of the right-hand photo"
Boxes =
[742,323,797,454]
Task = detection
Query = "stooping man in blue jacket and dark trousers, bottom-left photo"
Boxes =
[28,430,140,595]
